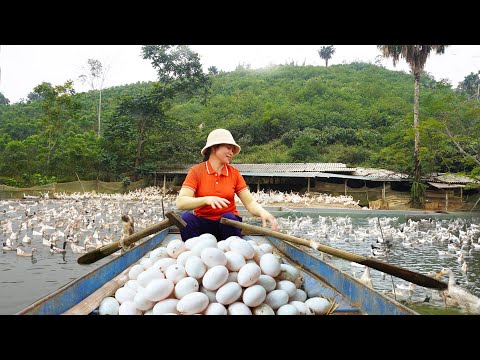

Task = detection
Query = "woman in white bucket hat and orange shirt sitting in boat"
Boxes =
[176,129,278,241]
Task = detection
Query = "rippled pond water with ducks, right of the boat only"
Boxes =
[266,212,480,314]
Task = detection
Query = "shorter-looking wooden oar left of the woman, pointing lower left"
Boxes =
[77,211,187,265]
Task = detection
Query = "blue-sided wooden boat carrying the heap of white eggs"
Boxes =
[16,228,418,315]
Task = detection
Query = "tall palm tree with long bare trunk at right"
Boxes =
[377,45,448,207]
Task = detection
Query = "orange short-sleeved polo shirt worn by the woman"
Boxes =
[182,161,248,220]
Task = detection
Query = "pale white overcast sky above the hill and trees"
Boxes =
[0,45,480,104]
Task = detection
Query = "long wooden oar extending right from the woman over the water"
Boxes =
[220,218,448,290]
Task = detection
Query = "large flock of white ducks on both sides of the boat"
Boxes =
[0,187,480,313]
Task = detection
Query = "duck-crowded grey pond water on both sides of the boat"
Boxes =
[0,200,480,314]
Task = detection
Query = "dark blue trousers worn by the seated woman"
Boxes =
[180,211,242,241]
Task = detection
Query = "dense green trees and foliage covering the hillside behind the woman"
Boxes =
[0,60,480,185]
